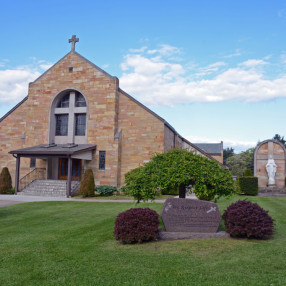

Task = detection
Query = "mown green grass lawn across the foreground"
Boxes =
[0,197,286,286]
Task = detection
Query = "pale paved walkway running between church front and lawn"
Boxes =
[0,195,196,207]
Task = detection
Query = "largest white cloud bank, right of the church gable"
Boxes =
[120,45,286,106]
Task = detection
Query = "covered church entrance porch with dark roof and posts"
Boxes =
[9,144,96,197]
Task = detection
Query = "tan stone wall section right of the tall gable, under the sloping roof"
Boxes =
[119,93,164,183]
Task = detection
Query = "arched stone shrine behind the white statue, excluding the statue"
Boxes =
[254,140,286,188]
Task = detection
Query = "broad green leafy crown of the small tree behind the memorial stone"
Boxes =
[125,149,234,202]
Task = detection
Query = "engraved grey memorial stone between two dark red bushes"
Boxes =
[161,198,221,233]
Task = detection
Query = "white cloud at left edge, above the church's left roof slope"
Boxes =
[0,68,40,103]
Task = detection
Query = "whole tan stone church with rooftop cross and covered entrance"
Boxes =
[0,36,214,196]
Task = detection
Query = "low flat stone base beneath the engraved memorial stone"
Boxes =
[158,231,230,240]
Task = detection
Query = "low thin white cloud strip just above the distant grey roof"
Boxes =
[186,136,257,153]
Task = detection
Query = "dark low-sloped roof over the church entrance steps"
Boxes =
[9,144,96,157]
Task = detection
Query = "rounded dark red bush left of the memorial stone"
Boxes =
[114,208,159,243]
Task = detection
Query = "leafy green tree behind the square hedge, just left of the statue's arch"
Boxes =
[226,148,254,176]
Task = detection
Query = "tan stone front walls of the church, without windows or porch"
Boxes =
[0,47,214,189]
